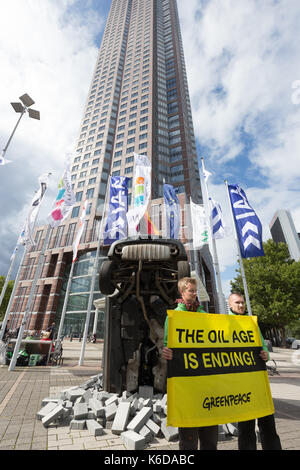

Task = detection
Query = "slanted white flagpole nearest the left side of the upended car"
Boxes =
[78,175,111,366]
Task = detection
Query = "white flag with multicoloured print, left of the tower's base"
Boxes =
[48,157,75,228]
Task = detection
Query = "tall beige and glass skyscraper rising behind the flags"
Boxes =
[10,0,215,334]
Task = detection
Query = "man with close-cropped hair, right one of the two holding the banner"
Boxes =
[228,292,281,450]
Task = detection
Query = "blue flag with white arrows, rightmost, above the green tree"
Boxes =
[228,184,264,258]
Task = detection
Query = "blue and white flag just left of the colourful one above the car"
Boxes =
[103,176,129,245]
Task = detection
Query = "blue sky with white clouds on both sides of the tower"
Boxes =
[0,0,300,295]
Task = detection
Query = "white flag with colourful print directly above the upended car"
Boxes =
[127,153,151,236]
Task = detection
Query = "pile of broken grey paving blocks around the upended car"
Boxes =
[36,374,235,450]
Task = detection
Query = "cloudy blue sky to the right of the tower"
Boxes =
[178,0,300,292]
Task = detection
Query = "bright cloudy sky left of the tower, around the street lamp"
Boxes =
[0,0,104,274]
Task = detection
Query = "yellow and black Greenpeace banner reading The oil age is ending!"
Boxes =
[167,310,274,427]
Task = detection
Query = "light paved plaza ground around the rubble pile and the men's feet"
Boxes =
[0,340,300,452]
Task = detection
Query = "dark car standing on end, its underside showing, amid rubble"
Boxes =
[99,236,190,393]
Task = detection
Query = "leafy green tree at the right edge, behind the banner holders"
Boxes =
[231,240,300,344]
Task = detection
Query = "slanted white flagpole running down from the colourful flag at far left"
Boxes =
[8,225,51,371]
